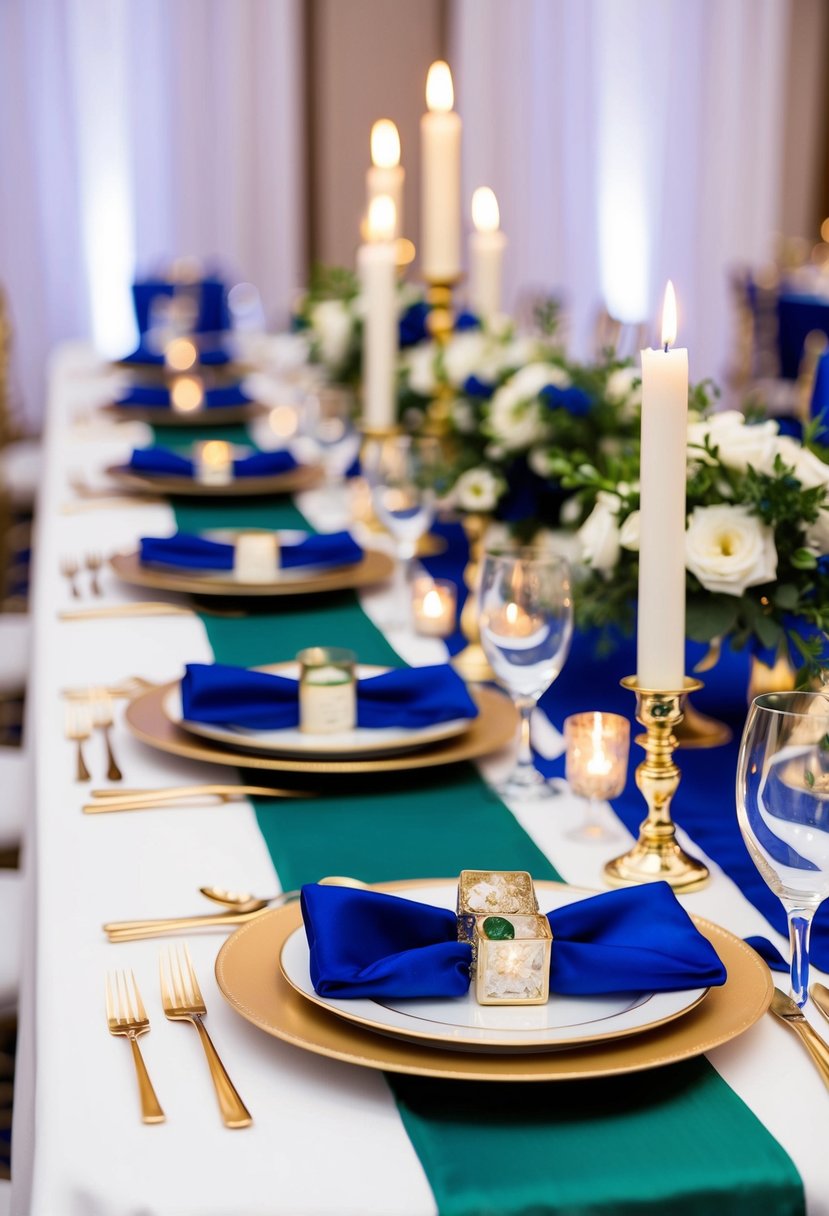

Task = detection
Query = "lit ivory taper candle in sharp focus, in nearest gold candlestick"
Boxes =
[637,281,688,689]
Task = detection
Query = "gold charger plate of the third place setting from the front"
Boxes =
[109,548,394,598]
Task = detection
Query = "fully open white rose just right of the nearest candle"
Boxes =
[686,505,777,596]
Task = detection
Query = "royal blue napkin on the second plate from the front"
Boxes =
[181,663,478,731]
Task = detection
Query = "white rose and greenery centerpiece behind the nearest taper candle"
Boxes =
[549,406,829,672]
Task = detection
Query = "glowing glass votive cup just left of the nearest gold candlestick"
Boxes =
[564,710,631,800]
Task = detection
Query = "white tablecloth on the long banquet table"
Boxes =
[12,344,829,1216]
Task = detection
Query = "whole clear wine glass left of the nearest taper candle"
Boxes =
[478,548,573,798]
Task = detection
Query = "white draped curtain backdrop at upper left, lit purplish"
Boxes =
[0,0,304,426]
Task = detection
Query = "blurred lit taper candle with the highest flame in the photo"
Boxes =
[421,60,461,282]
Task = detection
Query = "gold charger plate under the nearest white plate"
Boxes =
[215,879,773,1081]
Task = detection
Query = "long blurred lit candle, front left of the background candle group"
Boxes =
[357,195,397,430]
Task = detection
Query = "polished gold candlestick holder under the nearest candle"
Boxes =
[604,676,710,891]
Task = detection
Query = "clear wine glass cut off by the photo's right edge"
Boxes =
[737,692,829,1007]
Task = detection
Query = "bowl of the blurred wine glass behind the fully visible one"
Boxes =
[366,435,441,575]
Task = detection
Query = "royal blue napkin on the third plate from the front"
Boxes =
[141,531,362,574]
